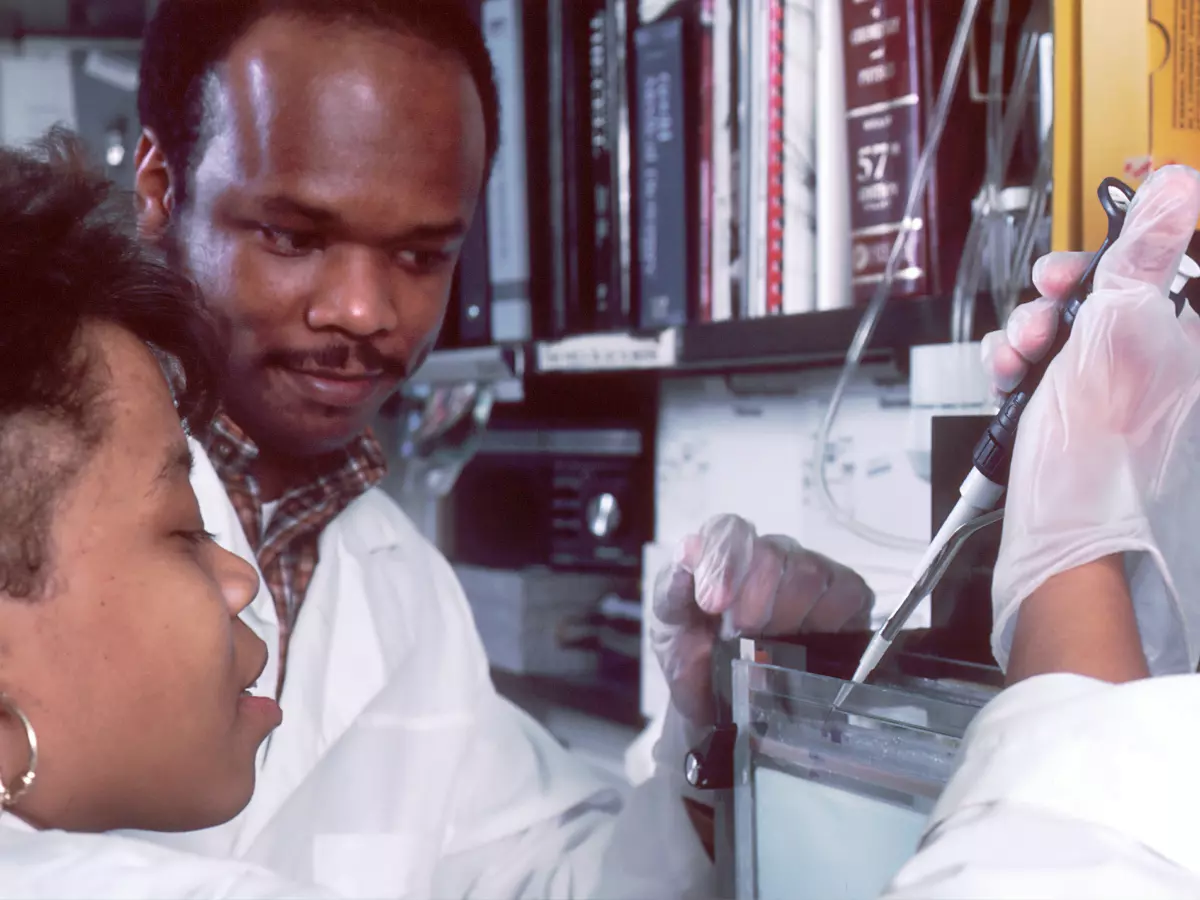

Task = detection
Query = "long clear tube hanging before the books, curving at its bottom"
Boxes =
[812,0,980,551]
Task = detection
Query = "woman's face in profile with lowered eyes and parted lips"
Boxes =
[0,325,281,832]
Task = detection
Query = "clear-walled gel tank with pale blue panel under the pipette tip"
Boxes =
[718,642,998,900]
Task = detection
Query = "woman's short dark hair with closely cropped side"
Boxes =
[0,128,218,598]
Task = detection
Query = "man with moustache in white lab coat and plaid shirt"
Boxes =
[119,0,870,898]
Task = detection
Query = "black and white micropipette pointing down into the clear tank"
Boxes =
[829,178,1147,714]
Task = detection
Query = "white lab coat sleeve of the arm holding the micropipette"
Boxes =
[884,674,1200,900]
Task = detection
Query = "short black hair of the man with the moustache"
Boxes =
[138,0,500,203]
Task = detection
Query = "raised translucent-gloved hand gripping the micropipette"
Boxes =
[984,167,1200,674]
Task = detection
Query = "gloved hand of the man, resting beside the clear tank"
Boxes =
[649,515,874,726]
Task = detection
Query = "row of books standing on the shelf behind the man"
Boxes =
[443,0,1037,346]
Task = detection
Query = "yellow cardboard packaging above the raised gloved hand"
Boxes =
[1052,0,1200,250]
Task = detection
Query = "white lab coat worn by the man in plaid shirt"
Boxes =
[126,445,710,899]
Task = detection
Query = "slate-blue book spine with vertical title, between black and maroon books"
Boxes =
[634,18,695,328]
